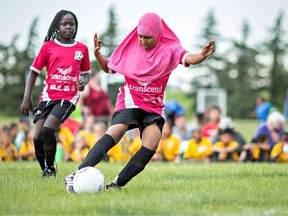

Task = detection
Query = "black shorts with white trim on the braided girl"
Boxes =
[33,100,75,123]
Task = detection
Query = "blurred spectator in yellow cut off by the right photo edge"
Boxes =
[271,132,288,163]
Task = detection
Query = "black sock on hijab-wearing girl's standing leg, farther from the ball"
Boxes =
[116,146,155,187]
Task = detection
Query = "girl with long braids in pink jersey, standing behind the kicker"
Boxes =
[19,10,91,177]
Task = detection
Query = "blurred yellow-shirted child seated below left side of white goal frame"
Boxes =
[184,128,212,162]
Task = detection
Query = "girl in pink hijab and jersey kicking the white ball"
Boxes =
[65,13,215,193]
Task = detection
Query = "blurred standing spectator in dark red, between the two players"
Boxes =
[79,73,112,126]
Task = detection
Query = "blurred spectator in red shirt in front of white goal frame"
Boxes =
[201,106,221,139]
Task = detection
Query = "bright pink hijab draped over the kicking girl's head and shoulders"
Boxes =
[108,13,183,82]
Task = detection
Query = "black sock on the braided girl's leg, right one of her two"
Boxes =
[42,127,57,169]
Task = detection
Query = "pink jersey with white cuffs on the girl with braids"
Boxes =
[30,40,91,105]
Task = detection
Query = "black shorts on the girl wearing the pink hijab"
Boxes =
[111,108,165,137]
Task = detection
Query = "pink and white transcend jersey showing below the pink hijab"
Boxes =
[115,50,186,115]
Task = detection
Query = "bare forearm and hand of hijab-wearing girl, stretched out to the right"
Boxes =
[185,40,215,65]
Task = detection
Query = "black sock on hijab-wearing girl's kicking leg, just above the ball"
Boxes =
[78,134,115,169]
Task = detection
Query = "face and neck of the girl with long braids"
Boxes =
[59,14,76,43]
